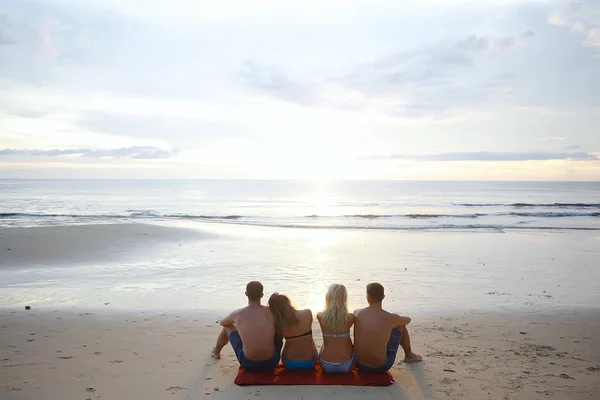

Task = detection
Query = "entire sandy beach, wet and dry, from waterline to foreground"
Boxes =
[0,224,600,400]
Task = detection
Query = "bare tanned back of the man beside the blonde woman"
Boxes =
[354,307,402,367]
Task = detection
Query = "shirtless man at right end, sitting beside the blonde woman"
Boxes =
[354,283,421,372]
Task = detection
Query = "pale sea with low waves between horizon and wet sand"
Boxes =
[0,180,600,231]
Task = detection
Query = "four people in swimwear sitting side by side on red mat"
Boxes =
[211,281,421,373]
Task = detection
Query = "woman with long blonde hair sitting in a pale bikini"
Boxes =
[317,284,356,374]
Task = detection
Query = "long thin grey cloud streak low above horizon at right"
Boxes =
[362,151,600,161]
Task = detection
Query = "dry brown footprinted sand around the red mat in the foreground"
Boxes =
[0,308,600,400]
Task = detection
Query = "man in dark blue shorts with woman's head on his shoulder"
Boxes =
[211,281,283,371]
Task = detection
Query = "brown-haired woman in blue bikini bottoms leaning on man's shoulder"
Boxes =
[269,293,317,370]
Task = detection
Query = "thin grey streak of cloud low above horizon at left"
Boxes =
[0,146,179,160]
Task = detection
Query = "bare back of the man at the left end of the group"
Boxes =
[232,305,275,361]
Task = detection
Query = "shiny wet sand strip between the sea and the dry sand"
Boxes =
[0,223,600,314]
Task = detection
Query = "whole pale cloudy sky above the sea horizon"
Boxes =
[0,0,600,180]
